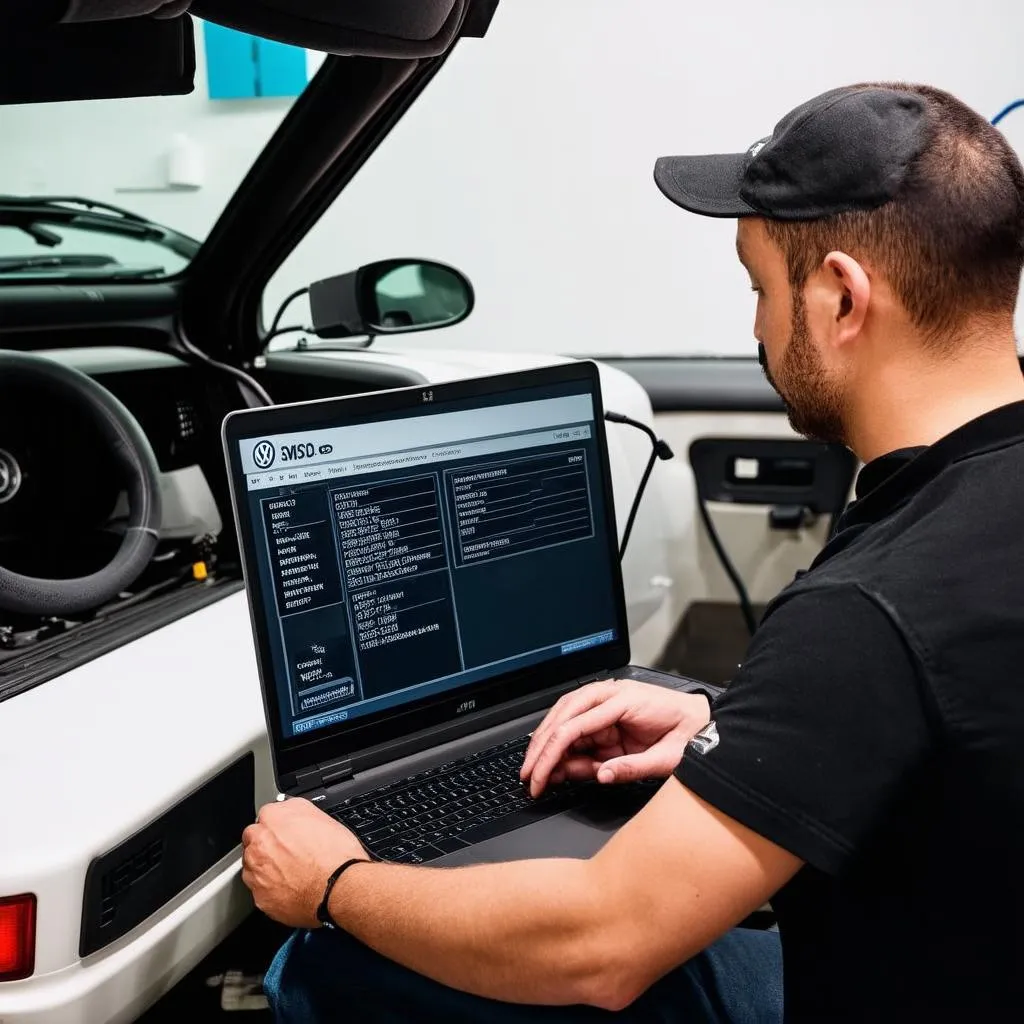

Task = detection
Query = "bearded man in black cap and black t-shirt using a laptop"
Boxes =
[244,85,1024,1024]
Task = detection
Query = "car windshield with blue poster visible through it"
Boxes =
[0,20,323,285]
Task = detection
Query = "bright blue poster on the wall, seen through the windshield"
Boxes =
[203,22,309,99]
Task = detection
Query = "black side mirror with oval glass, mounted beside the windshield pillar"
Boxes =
[309,259,474,338]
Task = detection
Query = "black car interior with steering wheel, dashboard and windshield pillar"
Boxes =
[0,0,495,712]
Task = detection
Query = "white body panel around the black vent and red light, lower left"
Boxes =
[0,594,264,1022]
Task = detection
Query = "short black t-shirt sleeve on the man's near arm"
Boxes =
[676,587,929,874]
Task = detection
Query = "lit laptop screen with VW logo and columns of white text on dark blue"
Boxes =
[240,382,617,736]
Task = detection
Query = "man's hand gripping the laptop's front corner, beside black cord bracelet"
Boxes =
[242,799,369,928]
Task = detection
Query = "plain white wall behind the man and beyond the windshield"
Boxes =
[0,0,1024,354]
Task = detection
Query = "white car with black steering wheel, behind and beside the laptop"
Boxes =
[0,0,853,1024]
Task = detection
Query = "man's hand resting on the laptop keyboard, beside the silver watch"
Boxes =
[520,680,711,797]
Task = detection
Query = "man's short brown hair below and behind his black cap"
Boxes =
[766,83,1024,342]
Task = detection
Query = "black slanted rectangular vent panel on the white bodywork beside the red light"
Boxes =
[79,753,255,956]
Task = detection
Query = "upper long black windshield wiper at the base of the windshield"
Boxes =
[0,196,201,260]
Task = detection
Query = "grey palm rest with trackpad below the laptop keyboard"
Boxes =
[430,794,649,867]
